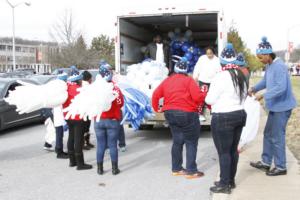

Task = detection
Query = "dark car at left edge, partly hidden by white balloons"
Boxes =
[0,78,45,131]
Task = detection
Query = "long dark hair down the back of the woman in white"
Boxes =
[228,68,249,103]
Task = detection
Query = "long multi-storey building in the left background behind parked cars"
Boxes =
[0,38,59,74]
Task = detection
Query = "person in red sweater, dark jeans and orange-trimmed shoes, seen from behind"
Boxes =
[152,61,205,179]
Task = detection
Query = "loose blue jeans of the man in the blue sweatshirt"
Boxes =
[261,110,292,170]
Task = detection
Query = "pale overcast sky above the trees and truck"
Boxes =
[0,0,300,51]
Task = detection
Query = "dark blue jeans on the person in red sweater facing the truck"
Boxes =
[165,110,200,174]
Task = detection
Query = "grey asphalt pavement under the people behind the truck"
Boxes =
[0,124,218,200]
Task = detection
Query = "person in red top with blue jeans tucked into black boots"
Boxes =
[94,63,124,175]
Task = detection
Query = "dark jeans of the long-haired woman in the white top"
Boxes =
[211,110,247,185]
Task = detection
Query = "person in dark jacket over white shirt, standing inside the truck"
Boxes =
[145,34,171,71]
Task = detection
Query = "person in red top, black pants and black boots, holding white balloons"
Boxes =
[63,70,92,170]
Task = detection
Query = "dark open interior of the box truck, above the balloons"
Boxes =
[116,12,219,74]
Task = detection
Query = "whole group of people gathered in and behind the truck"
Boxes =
[42,37,296,193]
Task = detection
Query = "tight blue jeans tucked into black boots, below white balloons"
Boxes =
[94,119,120,163]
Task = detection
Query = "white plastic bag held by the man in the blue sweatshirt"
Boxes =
[239,96,260,149]
